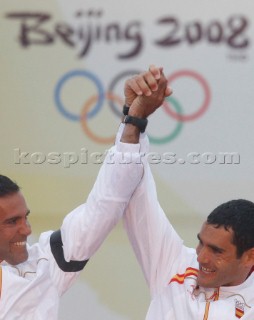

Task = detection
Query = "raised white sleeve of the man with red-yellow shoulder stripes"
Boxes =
[124,138,184,294]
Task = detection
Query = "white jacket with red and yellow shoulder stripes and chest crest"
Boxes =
[124,127,254,320]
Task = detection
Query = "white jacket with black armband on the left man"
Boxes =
[0,124,143,320]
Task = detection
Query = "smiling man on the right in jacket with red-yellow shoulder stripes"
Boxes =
[121,66,254,320]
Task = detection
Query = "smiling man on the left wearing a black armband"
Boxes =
[0,135,153,320]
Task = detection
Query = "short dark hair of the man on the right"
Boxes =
[207,199,254,258]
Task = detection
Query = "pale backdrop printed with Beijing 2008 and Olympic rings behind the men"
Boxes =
[0,0,254,320]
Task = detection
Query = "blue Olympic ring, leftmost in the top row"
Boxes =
[54,70,104,121]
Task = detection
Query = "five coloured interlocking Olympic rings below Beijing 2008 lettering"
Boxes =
[54,70,211,144]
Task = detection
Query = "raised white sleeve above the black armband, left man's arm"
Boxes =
[61,126,143,261]
